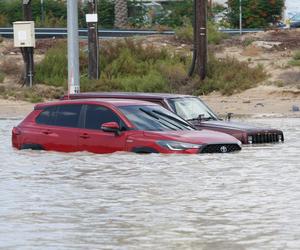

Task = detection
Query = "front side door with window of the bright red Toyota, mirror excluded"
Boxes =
[78,105,127,154]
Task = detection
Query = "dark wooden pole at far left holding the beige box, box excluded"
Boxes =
[21,0,34,87]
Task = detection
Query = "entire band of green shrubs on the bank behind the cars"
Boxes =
[35,39,267,94]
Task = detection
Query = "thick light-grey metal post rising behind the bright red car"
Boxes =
[67,0,80,94]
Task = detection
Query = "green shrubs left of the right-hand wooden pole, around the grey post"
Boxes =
[35,39,189,92]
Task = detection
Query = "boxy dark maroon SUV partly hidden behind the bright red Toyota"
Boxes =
[62,92,284,144]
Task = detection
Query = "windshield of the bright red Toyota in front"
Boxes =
[119,106,194,131]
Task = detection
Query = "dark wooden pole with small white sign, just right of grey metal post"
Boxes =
[86,0,99,80]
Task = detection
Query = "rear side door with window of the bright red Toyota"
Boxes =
[35,104,82,152]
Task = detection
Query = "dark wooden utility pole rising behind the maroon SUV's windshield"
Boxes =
[195,0,208,80]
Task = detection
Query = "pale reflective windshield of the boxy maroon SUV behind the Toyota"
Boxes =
[168,97,218,121]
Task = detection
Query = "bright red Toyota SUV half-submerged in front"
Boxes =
[12,99,241,154]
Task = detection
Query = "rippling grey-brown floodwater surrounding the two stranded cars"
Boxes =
[0,118,300,250]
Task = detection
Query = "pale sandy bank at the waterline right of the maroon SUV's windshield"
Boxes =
[201,86,300,118]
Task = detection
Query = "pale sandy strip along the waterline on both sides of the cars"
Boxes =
[0,86,300,119]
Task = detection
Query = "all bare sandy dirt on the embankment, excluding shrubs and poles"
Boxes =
[0,30,300,119]
